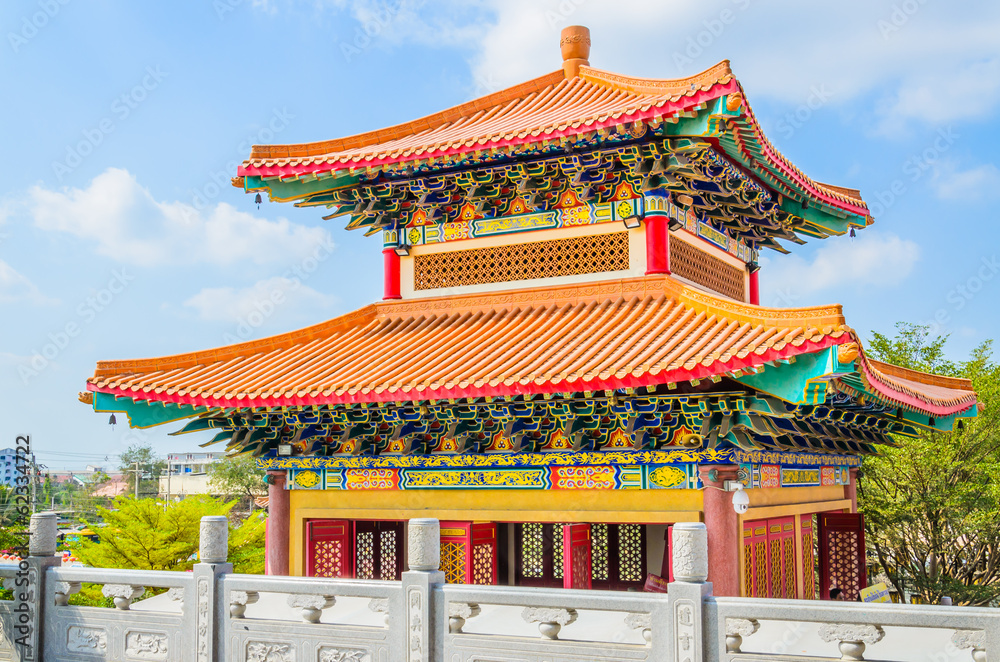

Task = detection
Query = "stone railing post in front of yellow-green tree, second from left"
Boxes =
[192,515,233,662]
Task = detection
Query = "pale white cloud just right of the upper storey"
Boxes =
[760,230,920,307]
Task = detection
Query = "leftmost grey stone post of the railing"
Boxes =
[23,513,62,661]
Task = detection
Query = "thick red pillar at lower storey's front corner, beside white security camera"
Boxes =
[698,464,741,597]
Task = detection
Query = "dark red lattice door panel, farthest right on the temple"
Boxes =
[819,513,868,602]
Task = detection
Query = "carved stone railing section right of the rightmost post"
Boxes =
[703,597,1000,662]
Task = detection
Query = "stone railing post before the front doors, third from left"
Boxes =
[404,518,447,662]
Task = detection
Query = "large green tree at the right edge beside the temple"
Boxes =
[858,324,1000,605]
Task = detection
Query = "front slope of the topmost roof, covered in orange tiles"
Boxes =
[239,61,738,176]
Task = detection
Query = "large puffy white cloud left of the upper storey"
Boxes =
[28,168,333,266]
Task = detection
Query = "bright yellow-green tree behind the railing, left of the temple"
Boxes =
[70,496,264,574]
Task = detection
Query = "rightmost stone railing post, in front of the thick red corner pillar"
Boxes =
[668,522,712,662]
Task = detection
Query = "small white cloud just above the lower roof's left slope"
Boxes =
[184,276,337,327]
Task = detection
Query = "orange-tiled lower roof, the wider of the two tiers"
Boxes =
[88,276,976,420]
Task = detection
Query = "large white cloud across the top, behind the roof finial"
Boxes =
[334,0,1000,130]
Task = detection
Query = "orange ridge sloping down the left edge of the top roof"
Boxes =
[248,69,567,161]
